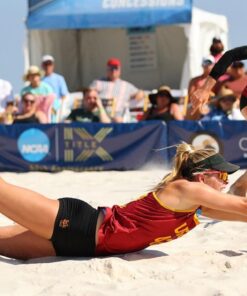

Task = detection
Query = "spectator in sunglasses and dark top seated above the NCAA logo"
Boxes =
[12,93,47,123]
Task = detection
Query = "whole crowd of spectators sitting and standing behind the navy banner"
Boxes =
[0,38,247,124]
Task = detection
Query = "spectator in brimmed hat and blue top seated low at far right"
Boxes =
[202,86,244,120]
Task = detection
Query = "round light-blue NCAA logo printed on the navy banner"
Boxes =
[17,128,50,162]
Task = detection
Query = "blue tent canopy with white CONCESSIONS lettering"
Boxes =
[27,0,192,30]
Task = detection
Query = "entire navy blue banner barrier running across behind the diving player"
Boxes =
[0,121,247,172]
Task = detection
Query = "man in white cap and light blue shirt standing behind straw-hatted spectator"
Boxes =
[42,55,69,122]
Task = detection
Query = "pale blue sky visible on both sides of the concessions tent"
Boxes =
[0,0,247,93]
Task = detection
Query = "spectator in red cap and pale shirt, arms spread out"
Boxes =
[90,58,144,122]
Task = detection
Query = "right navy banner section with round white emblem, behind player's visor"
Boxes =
[168,120,247,168]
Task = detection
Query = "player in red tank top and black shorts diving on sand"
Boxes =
[0,143,247,259]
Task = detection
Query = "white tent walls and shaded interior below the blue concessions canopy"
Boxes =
[28,8,228,91]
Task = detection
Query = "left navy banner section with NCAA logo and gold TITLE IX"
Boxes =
[0,122,167,172]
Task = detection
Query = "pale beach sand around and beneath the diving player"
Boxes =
[0,169,247,296]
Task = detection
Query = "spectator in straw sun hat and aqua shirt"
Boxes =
[21,66,55,122]
